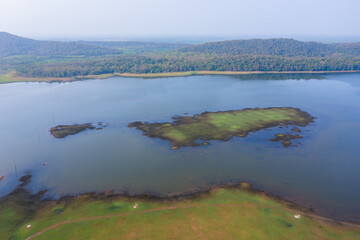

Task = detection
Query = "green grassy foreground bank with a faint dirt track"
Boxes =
[0,183,360,240]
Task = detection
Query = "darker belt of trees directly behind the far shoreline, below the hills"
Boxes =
[14,56,360,77]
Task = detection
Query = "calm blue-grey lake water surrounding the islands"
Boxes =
[0,73,360,221]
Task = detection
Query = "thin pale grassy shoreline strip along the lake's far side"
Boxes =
[0,70,360,84]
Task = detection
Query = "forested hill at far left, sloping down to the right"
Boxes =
[0,32,121,57]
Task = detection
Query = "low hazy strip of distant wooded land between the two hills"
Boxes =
[79,41,190,53]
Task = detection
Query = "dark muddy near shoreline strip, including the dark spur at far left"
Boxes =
[5,175,360,225]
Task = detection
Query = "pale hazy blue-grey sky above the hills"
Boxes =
[0,0,360,38]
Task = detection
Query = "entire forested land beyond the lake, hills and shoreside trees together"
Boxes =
[0,31,360,77]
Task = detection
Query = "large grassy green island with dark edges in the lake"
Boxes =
[128,107,314,149]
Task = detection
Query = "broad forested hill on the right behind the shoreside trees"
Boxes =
[179,38,360,57]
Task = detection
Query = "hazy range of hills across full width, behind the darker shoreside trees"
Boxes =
[0,32,360,57]
